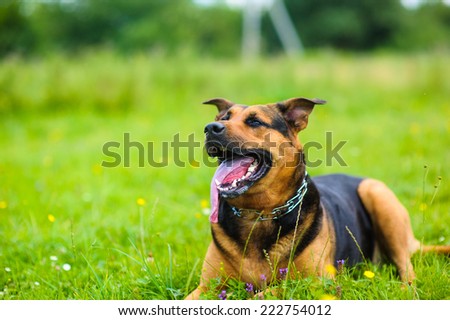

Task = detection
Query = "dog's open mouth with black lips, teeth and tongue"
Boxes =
[210,149,272,198]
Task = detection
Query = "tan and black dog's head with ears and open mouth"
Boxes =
[204,98,325,222]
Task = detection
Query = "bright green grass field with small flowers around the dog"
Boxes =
[0,52,450,299]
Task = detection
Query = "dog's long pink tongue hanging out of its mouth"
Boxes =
[209,157,255,223]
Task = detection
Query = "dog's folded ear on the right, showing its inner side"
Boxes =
[276,98,326,132]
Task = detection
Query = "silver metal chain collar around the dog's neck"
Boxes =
[231,172,308,221]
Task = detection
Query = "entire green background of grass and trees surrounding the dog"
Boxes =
[0,0,450,299]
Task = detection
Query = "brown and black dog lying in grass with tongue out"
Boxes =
[187,98,450,299]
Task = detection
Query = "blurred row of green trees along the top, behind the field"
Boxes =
[0,0,450,56]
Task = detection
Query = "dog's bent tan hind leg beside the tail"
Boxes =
[358,179,420,283]
